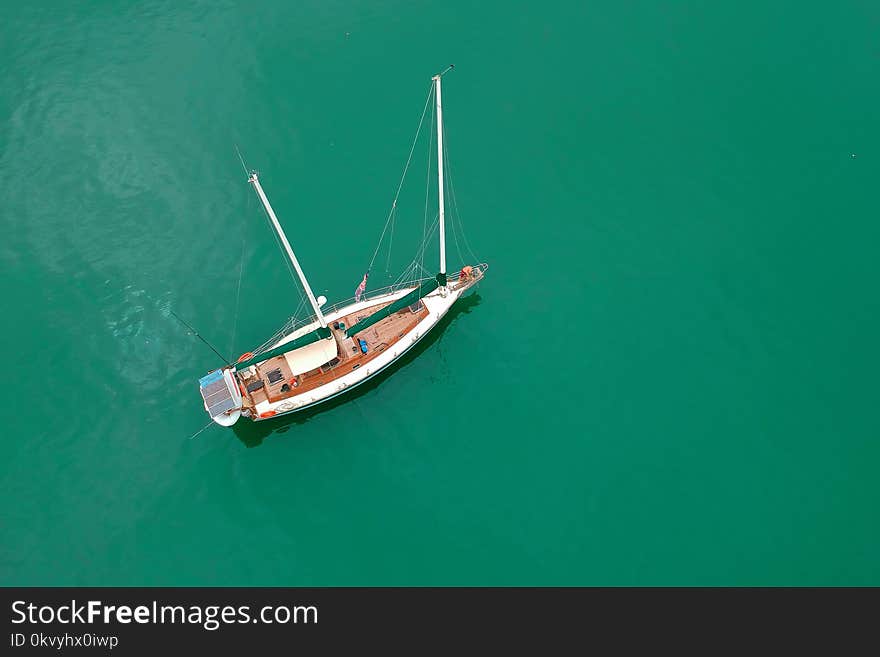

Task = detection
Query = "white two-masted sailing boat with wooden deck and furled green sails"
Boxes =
[199,66,488,426]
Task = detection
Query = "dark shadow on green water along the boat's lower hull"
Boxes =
[232,291,482,447]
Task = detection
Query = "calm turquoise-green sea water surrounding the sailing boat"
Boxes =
[0,1,880,585]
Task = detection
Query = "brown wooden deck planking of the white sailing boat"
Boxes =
[237,294,428,409]
